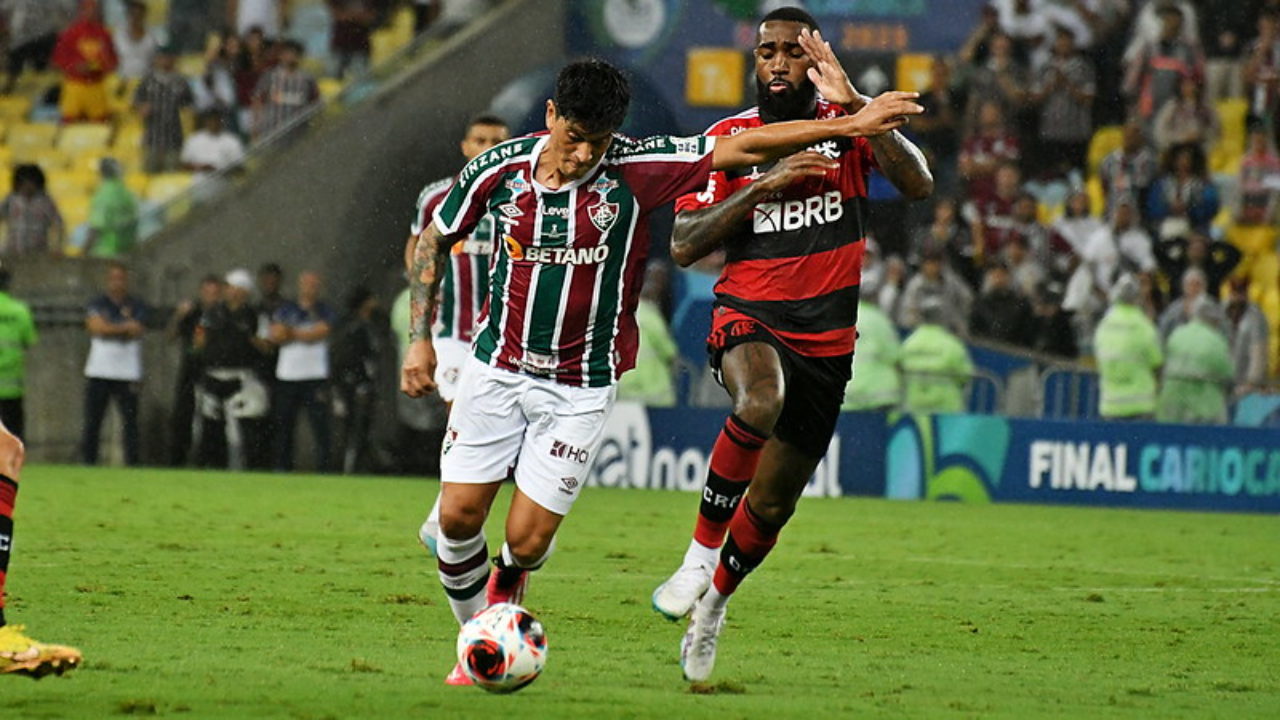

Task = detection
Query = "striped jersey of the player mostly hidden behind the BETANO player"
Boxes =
[410,177,494,343]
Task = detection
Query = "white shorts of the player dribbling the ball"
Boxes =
[440,357,617,515]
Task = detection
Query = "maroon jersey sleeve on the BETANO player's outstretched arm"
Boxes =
[616,135,716,210]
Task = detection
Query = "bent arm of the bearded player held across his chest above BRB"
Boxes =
[671,152,837,268]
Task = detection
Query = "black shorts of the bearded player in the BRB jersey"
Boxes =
[707,307,854,457]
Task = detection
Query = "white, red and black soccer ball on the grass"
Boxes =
[458,602,547,693]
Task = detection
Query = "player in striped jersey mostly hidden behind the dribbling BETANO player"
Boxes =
[404,115,511,555]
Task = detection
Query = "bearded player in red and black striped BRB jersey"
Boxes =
[653,8,933,680]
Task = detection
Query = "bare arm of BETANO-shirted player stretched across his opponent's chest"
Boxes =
[712,91,924,170]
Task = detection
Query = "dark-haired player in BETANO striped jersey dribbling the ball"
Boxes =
[401,60,923,684]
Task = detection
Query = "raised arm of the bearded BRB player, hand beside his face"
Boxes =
[800,29,933,200]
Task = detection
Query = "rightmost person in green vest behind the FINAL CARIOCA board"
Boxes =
[1156,299,1235,424]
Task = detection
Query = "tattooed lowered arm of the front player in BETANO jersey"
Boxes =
[401,223,453,397]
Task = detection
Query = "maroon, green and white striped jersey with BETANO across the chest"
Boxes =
[434,135,716,387]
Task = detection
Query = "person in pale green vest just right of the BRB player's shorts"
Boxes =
[840,286,902,410]
